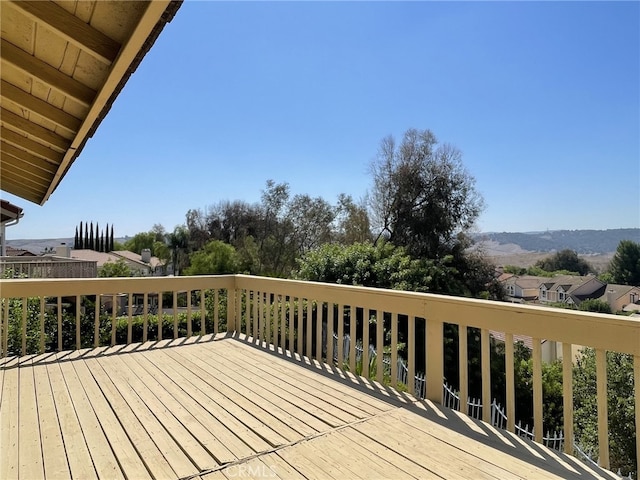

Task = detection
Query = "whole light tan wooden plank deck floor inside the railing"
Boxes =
[0,336,615,480]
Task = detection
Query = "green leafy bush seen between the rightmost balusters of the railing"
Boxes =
[573,348,638,478]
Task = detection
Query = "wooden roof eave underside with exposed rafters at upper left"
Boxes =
[0,0,182,205]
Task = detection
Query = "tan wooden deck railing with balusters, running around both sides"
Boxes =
[0,275,640,468]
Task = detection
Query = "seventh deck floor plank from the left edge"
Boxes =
[85,358,177,478]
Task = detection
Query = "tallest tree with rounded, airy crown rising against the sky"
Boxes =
[369,129,483,259]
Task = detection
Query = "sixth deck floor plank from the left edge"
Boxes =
[73,361,151,480]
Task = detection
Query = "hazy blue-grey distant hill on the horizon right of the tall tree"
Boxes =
[476,228,640,255]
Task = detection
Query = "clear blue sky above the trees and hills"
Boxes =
[3,1,640,239]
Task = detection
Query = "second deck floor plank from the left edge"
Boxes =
[18,363,44,478]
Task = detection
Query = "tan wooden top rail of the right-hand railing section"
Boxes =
[236,275,640,356]
